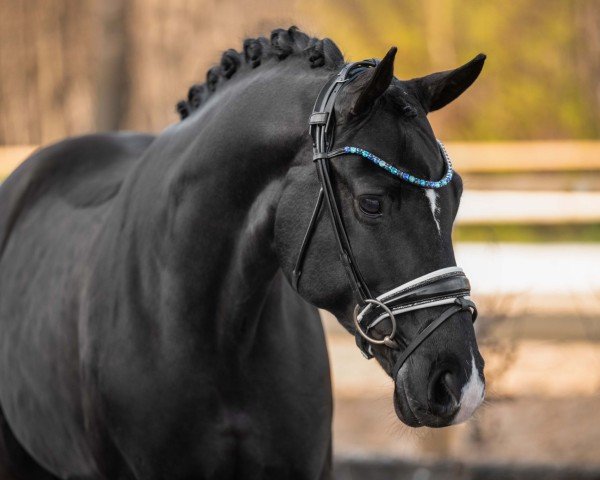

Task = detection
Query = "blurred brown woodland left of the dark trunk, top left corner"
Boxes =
[0,0,94,144]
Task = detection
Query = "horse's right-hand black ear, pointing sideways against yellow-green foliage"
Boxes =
[407,53,486,112]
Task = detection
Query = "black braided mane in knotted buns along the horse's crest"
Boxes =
[176,26,344,120]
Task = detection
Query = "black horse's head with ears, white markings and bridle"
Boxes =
[275,48,485,427]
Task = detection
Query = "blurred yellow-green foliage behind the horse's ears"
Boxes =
[302,0,600,140]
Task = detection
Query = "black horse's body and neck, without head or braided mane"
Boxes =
[0,62,332,479]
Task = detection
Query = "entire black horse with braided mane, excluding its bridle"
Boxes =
[0,27,484,480]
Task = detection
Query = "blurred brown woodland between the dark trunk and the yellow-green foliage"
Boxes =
[120,0,294,130]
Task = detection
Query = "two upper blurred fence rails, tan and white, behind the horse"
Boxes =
[0,141,600,225]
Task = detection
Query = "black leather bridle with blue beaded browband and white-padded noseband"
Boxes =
[292,60,477,379]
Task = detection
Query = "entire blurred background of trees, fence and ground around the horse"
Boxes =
[0,0,600,480]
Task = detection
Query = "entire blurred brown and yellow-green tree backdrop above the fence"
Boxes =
[0,0,600,144]
